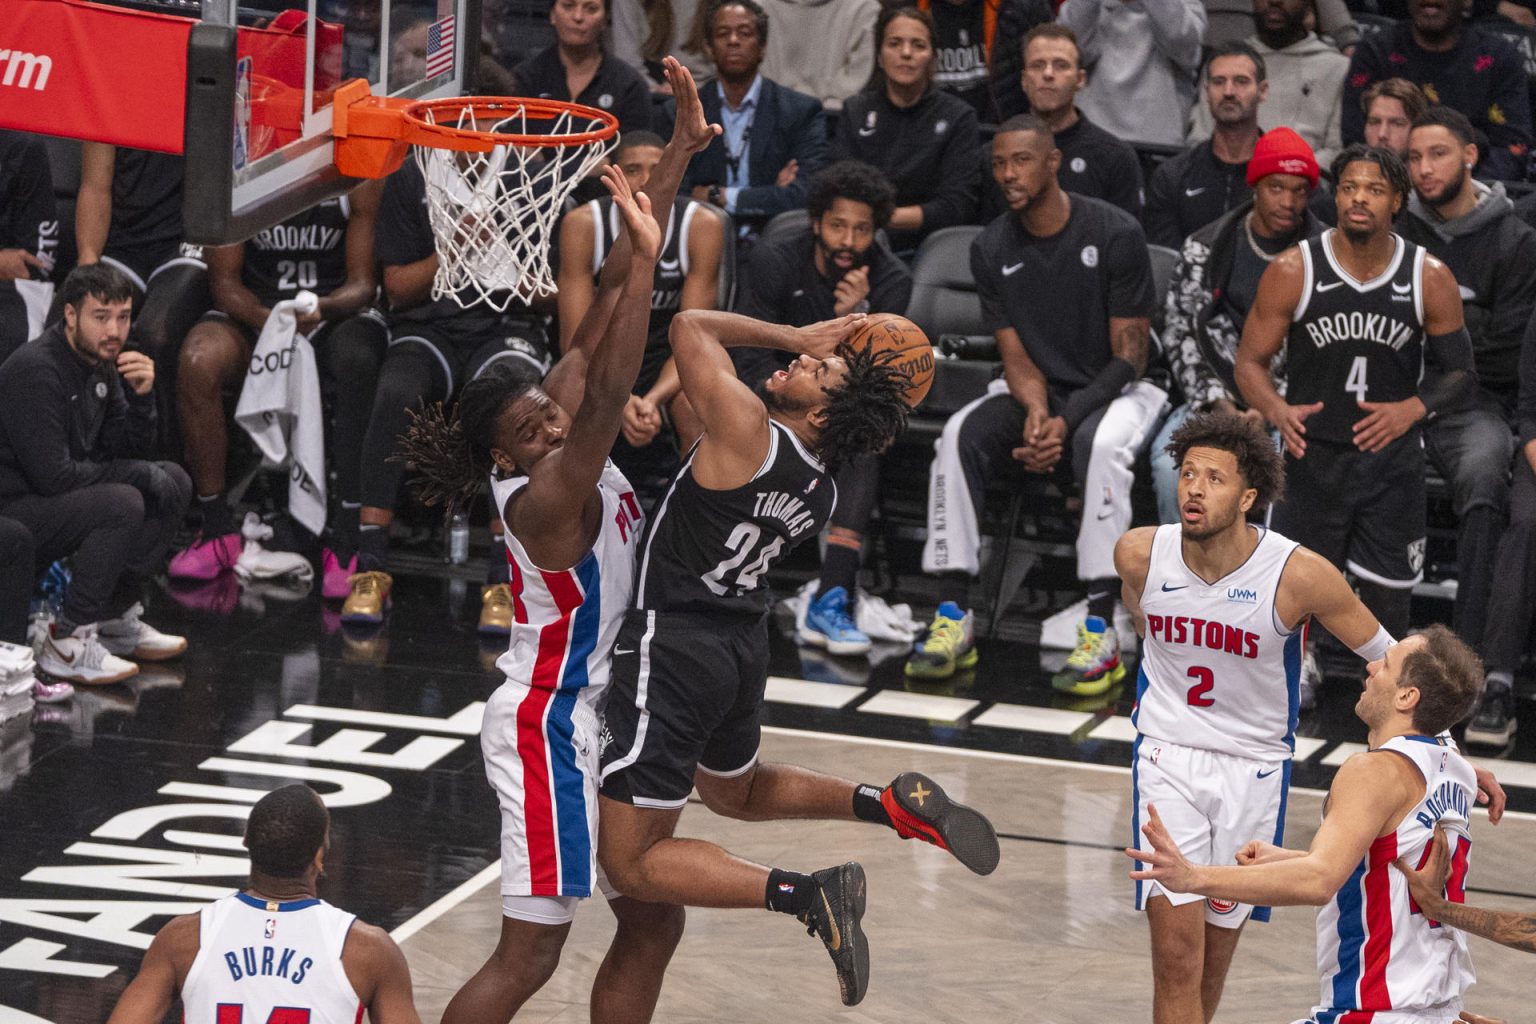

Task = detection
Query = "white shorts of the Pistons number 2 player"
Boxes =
[1130,735,1290,927]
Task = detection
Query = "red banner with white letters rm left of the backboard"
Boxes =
[0,0,192,154]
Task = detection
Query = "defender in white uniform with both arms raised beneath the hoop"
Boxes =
[407,58,719,1024]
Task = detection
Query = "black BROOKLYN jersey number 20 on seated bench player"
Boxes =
[240,195,352,307]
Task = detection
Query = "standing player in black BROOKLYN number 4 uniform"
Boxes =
[1236,146,1475,684]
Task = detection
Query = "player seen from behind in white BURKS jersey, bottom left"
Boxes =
[108,786,421,1024]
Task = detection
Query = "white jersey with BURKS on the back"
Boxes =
[181,892,362,1024]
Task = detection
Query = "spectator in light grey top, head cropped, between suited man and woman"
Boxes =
[762,0,880,112]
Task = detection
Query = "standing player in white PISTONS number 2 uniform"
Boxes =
[1115,411,1392,1024]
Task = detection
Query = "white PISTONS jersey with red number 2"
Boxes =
[1130,524,1303,761]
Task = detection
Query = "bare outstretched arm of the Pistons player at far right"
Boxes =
[1126,754,1409,907]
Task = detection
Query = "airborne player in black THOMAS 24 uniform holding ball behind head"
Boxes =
[599,310,998,1006]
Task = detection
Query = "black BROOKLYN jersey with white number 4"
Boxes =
[1286,229,1425,445]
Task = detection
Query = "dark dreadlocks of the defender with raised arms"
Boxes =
[392,364,538,517]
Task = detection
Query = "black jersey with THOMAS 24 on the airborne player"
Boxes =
[634,421,837,614]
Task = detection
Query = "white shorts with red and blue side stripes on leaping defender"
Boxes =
[481,680,601,901]
